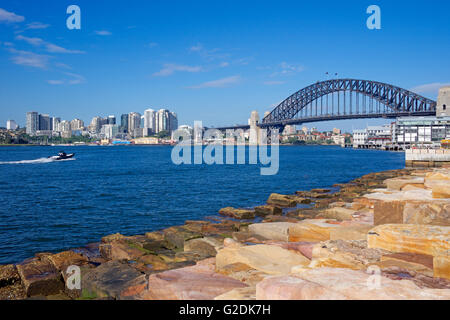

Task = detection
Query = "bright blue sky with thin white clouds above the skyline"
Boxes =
[0,0,450,130]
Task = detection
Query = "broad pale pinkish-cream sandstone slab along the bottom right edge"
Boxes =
[256,268,450,300]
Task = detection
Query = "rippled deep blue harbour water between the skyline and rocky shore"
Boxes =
[0,146,404,264]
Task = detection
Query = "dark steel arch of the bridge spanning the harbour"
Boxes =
[259,79,436,129]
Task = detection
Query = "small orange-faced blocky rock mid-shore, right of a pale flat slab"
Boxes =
[289,219,337,242]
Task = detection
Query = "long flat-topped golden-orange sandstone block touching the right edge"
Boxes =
[367,224,450,256]
